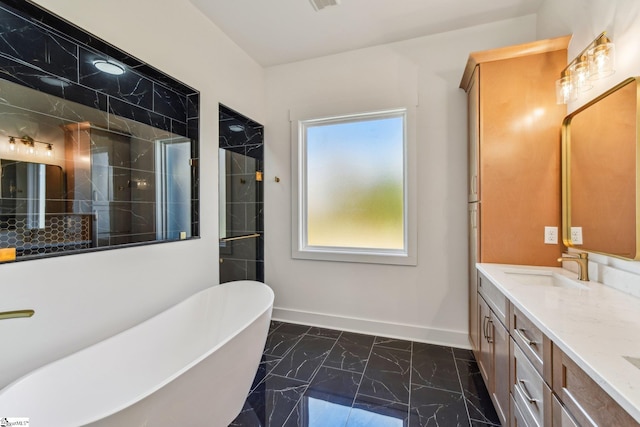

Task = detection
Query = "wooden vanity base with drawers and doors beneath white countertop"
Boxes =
[474,272,640,427]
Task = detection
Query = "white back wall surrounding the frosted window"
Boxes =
[265,15,536,347]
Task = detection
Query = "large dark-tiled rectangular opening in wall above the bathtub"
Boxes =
[0,1,199,261]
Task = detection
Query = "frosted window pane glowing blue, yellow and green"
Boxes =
[299,110,407,255]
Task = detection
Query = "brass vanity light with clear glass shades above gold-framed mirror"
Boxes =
[556,31,615,104]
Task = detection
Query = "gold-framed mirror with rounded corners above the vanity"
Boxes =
[562,78,640,259]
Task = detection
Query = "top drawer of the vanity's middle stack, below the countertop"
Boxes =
[509,305,551,383]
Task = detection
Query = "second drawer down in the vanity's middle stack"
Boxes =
[511,339,551,426]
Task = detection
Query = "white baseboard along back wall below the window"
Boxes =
[271,307,471,349]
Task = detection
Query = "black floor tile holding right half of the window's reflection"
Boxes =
[347,394,409,427]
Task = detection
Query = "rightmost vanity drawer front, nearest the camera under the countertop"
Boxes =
[553,345,640,427]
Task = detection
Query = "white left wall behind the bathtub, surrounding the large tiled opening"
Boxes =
[0,0,265,388]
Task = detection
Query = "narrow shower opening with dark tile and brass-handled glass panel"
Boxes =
[219,105,264,283]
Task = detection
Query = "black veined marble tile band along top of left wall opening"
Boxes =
[0,1,199,136]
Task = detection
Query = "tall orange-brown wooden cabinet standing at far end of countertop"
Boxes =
[460,36,570,267]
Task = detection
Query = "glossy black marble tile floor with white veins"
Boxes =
[231,322,500,427]
